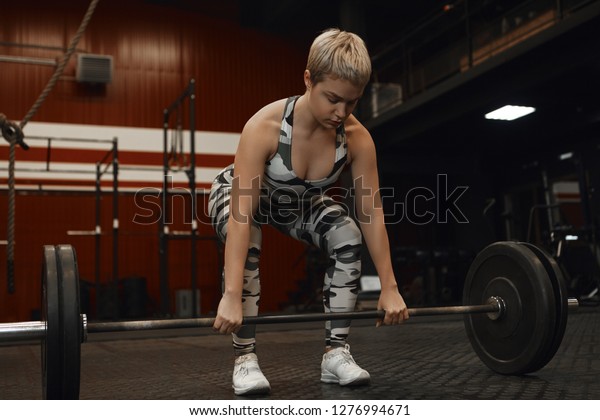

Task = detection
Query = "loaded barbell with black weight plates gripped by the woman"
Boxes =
[0,242,578,399]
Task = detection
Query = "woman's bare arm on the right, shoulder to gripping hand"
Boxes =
[348,123,408,324]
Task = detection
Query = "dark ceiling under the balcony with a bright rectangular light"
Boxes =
[367,2,600,184]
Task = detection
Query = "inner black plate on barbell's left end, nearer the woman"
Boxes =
[56,245,81,400]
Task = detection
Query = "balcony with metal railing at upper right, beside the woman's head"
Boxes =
[360,0,598,119]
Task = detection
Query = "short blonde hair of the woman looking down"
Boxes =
[306,28,371,88]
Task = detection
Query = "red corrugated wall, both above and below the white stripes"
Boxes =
[0,0,308,322]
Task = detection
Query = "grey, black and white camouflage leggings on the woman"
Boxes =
[208,169,362,354]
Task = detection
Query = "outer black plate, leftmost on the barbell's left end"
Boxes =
[41,245,63,399]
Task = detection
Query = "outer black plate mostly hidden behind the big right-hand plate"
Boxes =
[521,242,569,370]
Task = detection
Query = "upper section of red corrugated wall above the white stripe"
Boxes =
[0,0,308,132]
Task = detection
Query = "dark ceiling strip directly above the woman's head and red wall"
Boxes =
[145,0,446,53]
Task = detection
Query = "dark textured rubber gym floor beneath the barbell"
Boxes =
[0,307,600,400]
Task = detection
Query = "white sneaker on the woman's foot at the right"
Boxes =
[321,344,371,386]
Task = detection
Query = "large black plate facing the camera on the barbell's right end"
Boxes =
[463,242,556,375]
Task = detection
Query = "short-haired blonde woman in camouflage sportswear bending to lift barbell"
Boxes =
[209,29,408,395]
